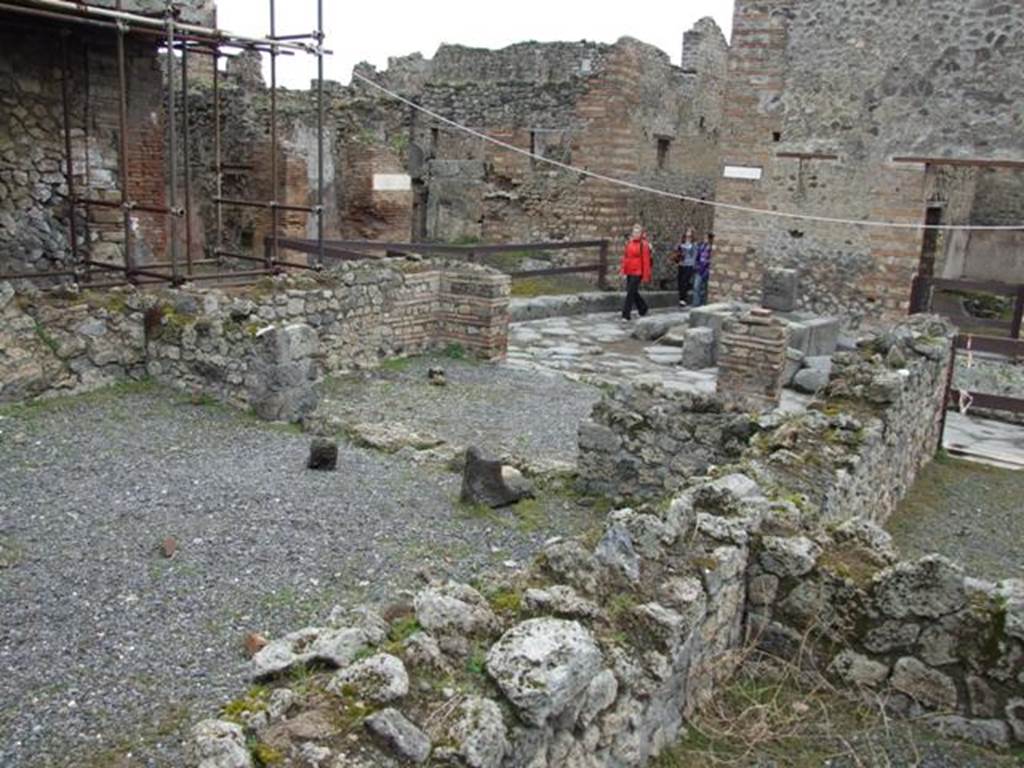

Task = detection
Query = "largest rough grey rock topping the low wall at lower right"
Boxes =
[874,555,967,618]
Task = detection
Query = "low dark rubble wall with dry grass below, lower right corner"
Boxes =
[748,518,1024,748]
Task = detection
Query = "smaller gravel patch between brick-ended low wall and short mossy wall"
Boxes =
[321,357,601,464]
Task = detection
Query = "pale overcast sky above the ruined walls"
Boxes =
[211,0,733,88]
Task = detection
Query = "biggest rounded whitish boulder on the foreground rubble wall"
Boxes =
[486,618,603,727]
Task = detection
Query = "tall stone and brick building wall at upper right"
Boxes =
[716,0,1024,318]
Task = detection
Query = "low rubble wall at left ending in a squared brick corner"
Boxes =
[0,262,509,419]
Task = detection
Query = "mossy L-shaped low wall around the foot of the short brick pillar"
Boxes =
[580,315,953,522]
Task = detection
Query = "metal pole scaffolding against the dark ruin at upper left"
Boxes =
[0,0,330,288]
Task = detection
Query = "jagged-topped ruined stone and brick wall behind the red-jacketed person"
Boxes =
[176,19,728,286]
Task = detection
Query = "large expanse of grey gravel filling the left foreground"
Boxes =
[0,385,599,768]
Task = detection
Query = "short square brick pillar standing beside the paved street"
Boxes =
[718,309,785,411]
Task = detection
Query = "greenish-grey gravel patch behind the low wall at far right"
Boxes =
[886,457,1024,581]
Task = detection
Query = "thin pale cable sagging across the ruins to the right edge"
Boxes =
[352,71,1024,231]
